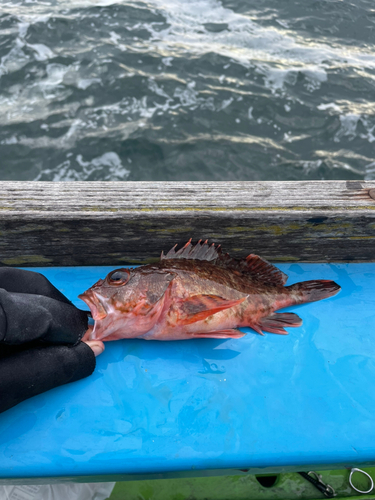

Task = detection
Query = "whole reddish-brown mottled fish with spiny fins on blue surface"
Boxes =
[79,239,341,341]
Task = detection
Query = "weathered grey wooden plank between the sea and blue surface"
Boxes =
[0,181,375,266]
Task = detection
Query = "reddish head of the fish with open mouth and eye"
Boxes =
[78,268,175,340]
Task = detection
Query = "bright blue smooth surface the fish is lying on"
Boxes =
[0,264,375,480]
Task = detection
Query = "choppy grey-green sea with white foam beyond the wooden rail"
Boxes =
[0,0,375,181]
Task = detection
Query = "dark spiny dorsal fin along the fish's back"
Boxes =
[160,238,288,286]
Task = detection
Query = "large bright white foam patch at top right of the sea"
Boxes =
[129,0,375,96]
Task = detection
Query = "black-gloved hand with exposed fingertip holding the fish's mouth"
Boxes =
[0,267,104,413]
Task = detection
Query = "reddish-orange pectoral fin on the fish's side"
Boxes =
[177,295,247,325]
